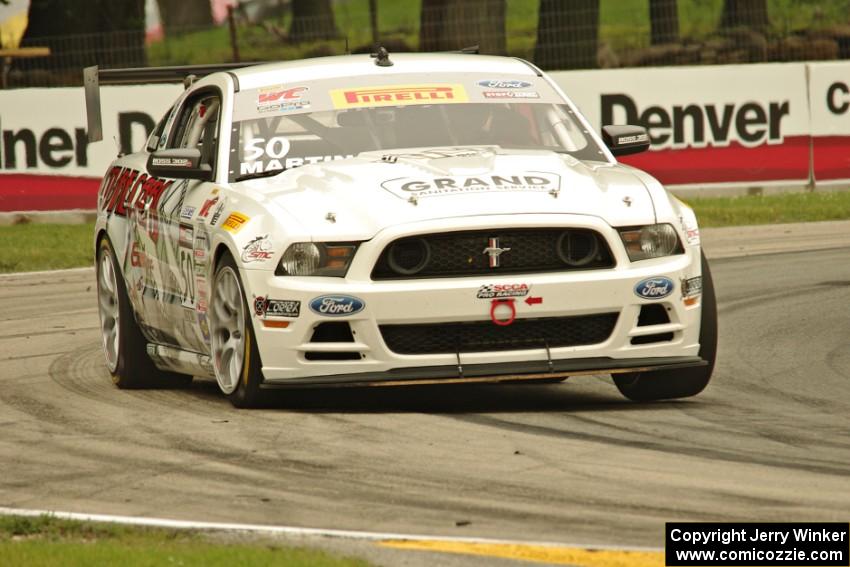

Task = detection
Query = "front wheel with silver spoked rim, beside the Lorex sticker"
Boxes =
[209,253,263,408]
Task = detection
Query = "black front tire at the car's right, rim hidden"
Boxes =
[613,254,717,402]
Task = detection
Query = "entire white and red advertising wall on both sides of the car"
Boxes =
[0,62,850,211]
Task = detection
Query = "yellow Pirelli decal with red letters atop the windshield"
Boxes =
[331,84,469,108]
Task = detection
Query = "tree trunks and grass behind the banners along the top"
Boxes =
[6,0,850,86]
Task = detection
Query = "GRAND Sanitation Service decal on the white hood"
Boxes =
[381,171,561,200]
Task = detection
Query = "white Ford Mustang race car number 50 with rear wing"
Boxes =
[87,50,717,407]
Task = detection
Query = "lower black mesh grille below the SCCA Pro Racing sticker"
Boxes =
[380,313,619,354]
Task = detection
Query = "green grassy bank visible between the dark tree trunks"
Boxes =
[148,0,850,65]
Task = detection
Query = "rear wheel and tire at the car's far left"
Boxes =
[97,236,192,390]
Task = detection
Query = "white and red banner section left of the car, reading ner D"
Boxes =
[0,85,182,211]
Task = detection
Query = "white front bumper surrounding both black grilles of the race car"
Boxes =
[242,215,701,386]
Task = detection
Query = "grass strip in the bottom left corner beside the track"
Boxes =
[0,516,369,567]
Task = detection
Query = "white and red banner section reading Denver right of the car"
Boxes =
[551,63,809,186]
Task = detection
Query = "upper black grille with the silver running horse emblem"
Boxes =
[372,228,615,280]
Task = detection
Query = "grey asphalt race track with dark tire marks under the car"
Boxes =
[0,248,850,560]
